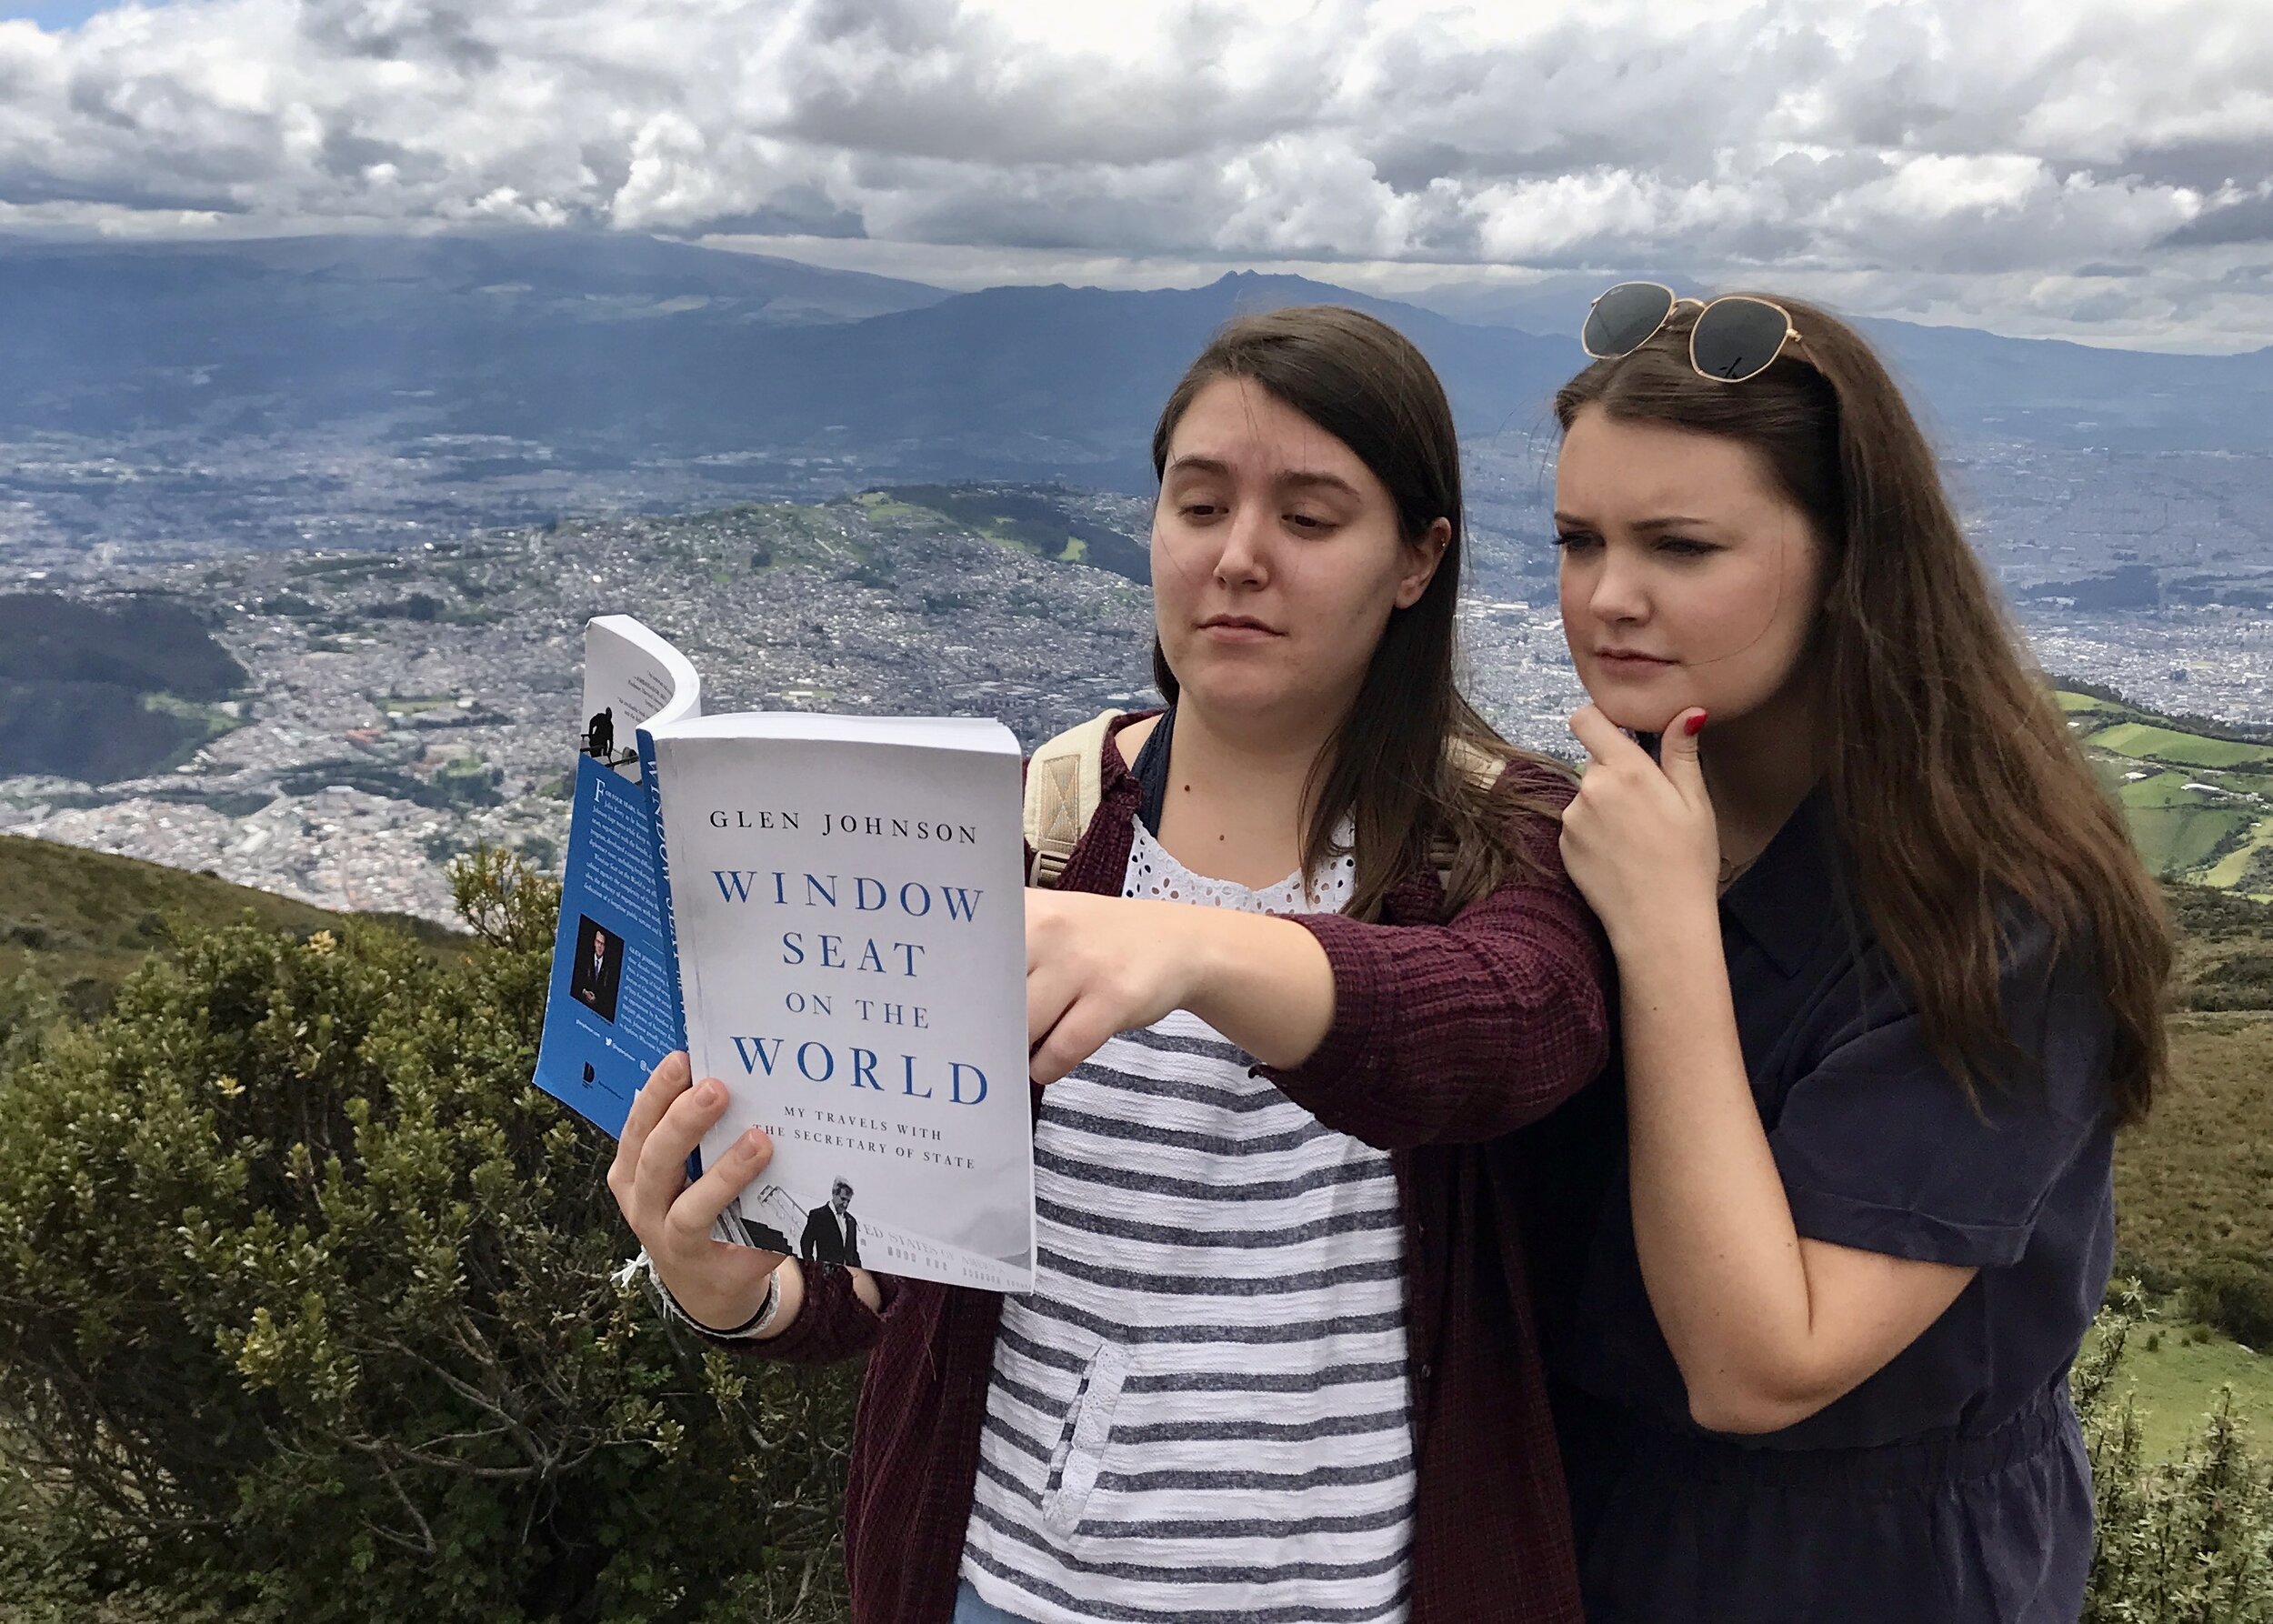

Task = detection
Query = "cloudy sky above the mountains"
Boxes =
[0,0,2273,350]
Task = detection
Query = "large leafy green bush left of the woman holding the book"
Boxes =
[0,853,853,1624]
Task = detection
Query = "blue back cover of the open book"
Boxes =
[536,755,686,1138]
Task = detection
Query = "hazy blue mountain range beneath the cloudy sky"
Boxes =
[0,232,2273,489]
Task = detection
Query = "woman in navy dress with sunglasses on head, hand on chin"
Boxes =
[1555,285,2171,1624]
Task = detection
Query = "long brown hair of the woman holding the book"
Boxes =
[1153,305,1557,919]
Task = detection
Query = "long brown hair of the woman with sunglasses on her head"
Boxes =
[1555,296,2171,1121]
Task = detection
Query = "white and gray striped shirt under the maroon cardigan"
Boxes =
[962,824,1414,1624]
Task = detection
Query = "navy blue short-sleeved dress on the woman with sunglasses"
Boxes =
[1544,794,2114,1624]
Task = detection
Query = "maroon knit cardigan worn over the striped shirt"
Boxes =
[700,717,1609,1624]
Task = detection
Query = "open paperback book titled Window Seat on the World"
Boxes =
[536,614,1035,1292]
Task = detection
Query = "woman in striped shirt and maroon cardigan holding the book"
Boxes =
[609,307,1607,1624]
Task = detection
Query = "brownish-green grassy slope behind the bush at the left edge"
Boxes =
[0,835,462,1010]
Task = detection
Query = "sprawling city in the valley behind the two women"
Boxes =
[13,461,2273,921]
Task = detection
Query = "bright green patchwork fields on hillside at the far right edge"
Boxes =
[2059,689,2273,898]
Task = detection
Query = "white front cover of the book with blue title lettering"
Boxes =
[650,712,1035,1292]
